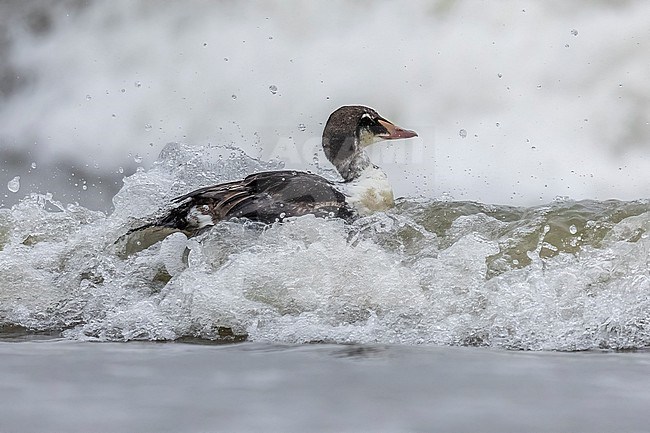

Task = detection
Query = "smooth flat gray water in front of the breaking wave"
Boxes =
[5,341,650,433]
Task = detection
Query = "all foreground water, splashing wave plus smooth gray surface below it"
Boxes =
[0,130,650,432]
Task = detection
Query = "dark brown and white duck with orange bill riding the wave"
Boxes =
[140,105,417,235]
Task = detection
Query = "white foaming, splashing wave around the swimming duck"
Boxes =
[0,144,650,350]
